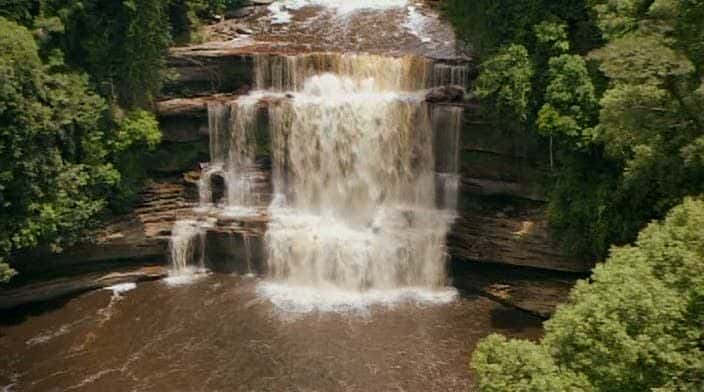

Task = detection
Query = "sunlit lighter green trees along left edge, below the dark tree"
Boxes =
[0,17,160,279]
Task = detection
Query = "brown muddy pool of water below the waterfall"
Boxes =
[0,275,541,391]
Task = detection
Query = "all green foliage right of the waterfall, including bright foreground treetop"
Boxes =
[445,0,704,391]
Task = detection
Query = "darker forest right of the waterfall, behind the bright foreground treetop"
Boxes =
[445,0,704,259]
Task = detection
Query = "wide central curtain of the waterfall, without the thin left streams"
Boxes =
[256,54,468,311]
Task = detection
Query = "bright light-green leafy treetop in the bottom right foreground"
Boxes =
[472,199,704,392]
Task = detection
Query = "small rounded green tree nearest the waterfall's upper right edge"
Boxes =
[474,45,533,120]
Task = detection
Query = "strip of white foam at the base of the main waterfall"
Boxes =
[257,282,457,313]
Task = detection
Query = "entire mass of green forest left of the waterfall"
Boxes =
[0,0,241,282]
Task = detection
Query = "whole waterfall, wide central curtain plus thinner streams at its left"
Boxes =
[162,54,467,311]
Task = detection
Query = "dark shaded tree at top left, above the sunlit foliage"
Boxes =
[60,0,171,108]
